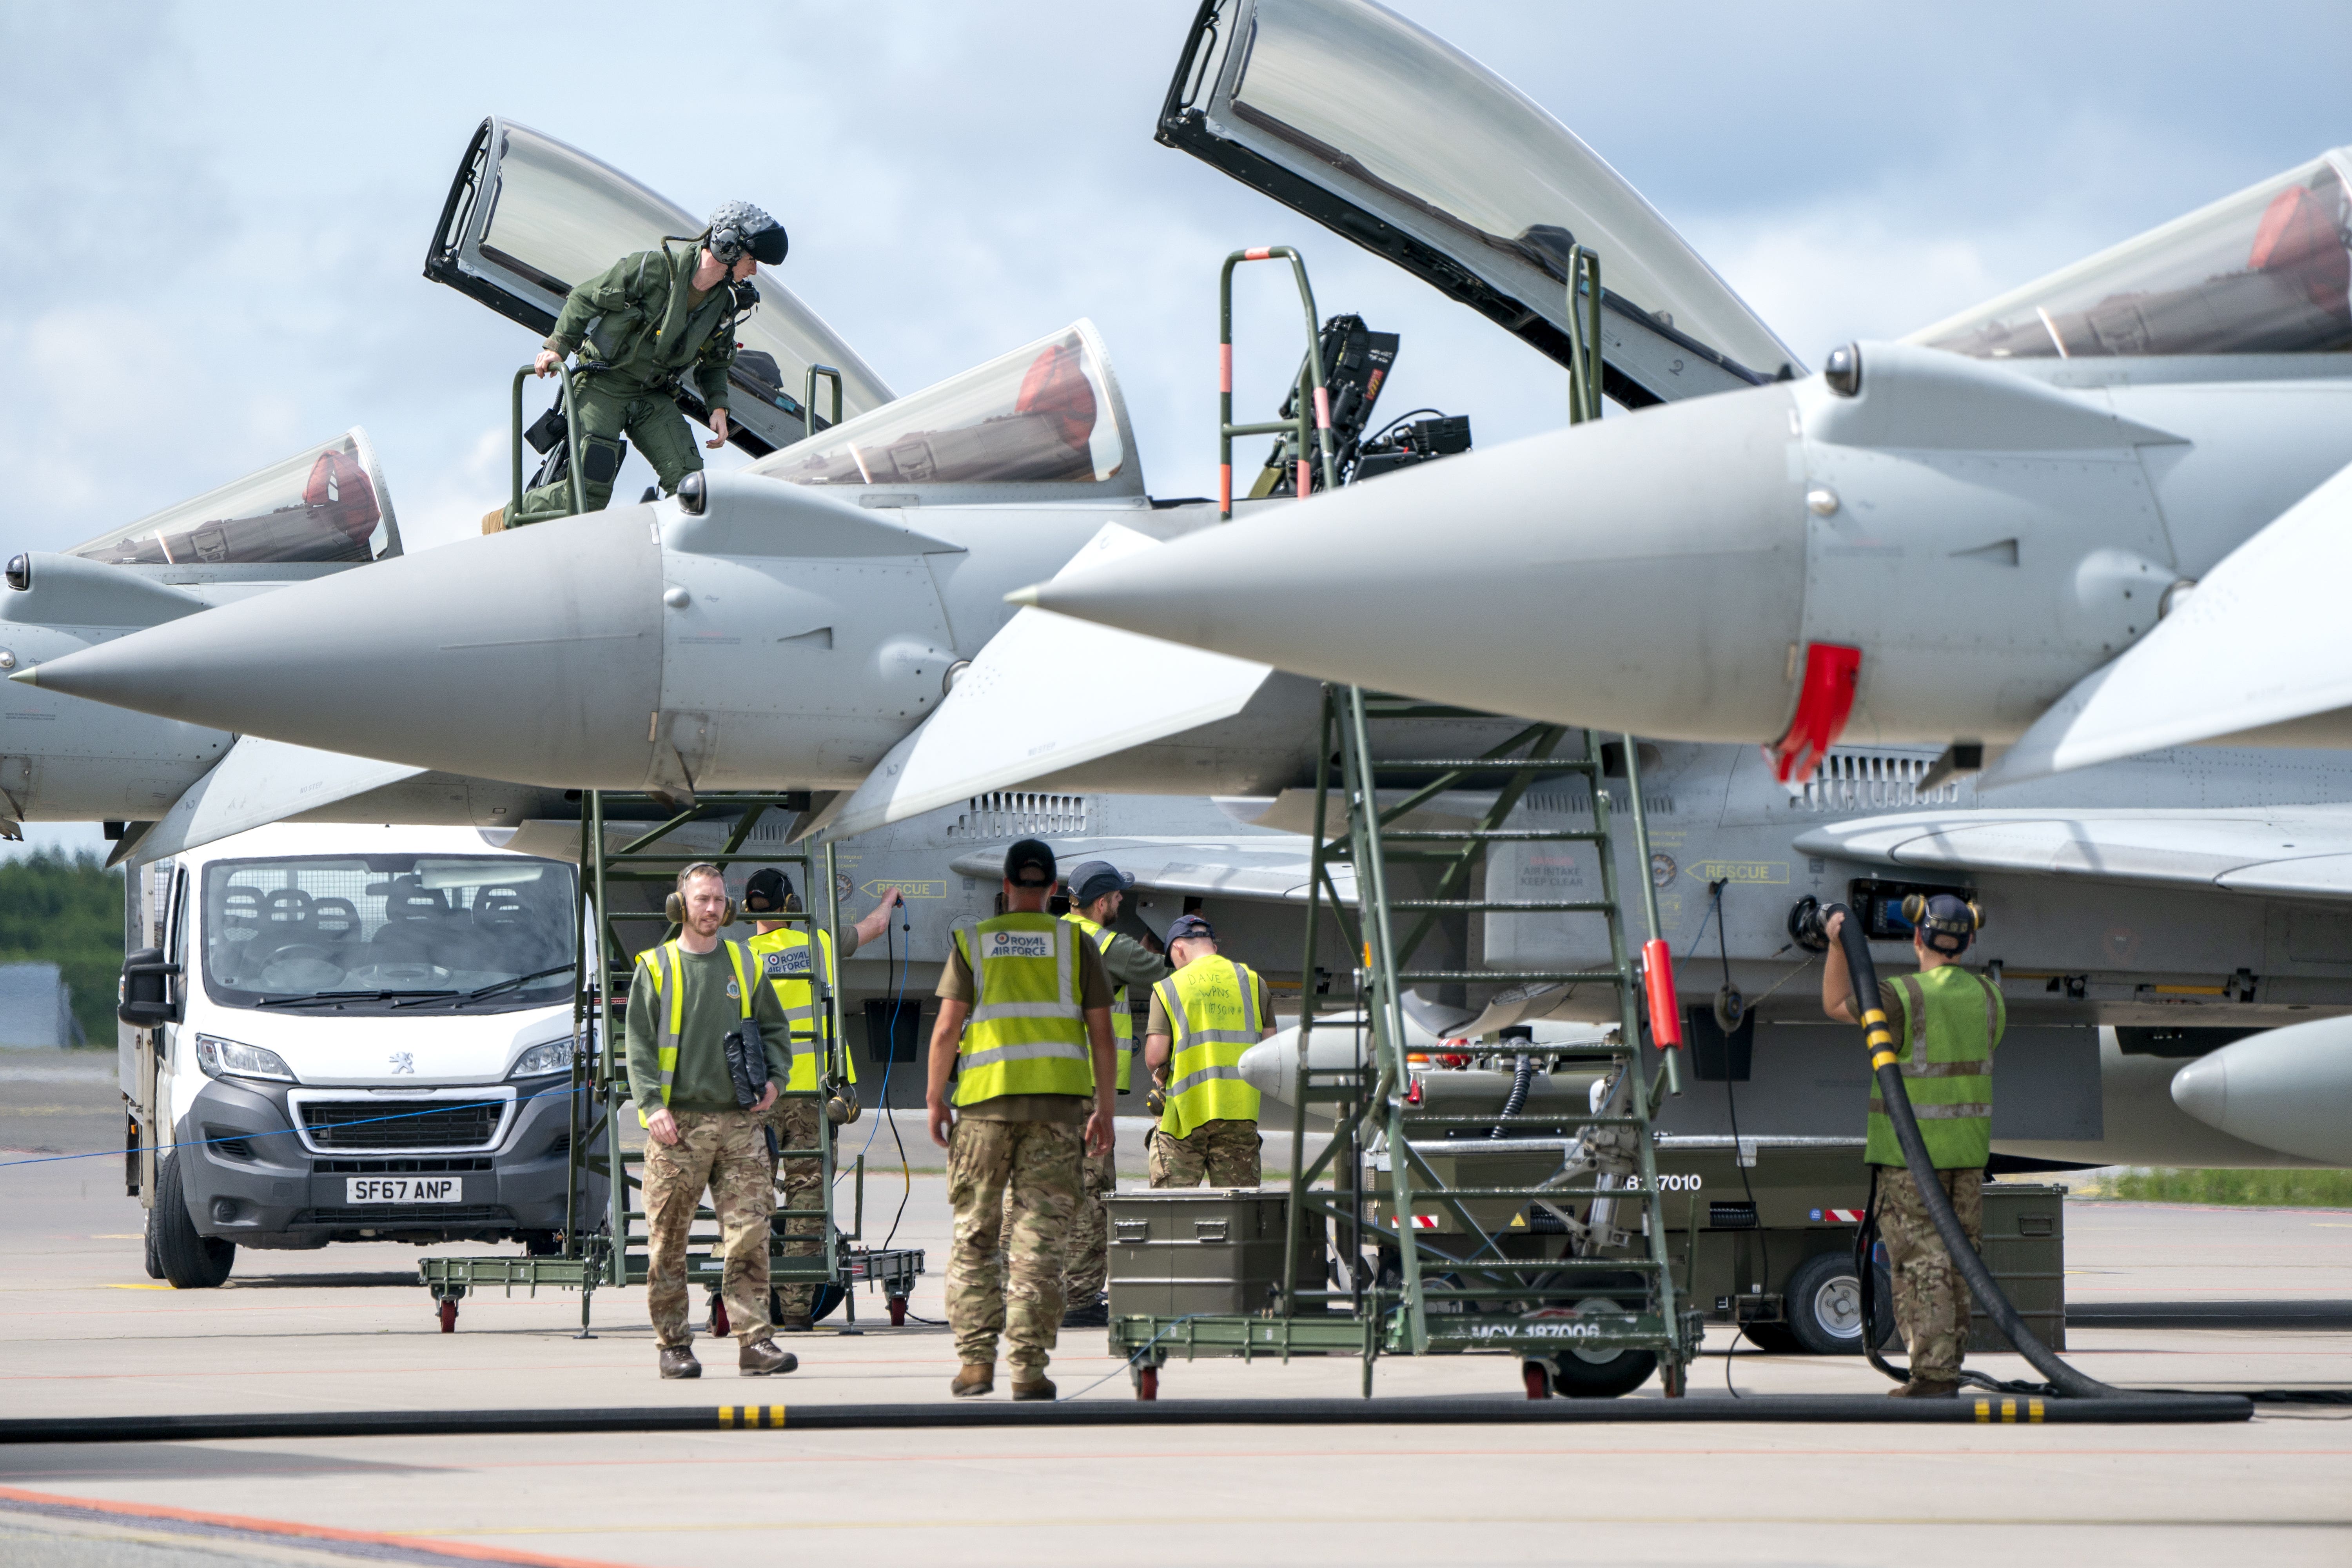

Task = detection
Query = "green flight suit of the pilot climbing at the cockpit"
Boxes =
[506,240,736,526]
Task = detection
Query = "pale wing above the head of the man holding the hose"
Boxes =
[1795,806,2352,898]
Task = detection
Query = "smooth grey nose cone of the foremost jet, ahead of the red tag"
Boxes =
[1016,386,1806,740]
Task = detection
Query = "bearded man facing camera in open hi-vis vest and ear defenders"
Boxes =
[628,860,800,1377]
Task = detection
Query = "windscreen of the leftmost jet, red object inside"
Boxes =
[71,425,400,566]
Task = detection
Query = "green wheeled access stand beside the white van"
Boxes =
[416,790,924,1338]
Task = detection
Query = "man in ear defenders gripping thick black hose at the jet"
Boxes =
[1820,893,2009,1399]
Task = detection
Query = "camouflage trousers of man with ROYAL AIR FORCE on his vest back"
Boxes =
[948,1119,1087,1377]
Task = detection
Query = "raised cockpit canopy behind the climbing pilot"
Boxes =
[426,118,891,456]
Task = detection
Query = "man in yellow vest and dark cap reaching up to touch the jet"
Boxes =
[743,865,906,1333]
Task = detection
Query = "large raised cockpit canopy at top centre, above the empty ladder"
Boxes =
[1160,0,1797,407]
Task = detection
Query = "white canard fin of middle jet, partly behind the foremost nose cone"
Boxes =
[811,522,1272,839]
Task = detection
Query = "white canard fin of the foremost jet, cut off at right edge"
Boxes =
[1983,454,2352,788]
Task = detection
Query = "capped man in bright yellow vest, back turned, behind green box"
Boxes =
[1143,915,1275,1187]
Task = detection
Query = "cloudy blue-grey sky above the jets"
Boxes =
[0,0,2352,860]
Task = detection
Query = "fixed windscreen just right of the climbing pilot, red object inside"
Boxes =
[746,322,1143,498]
